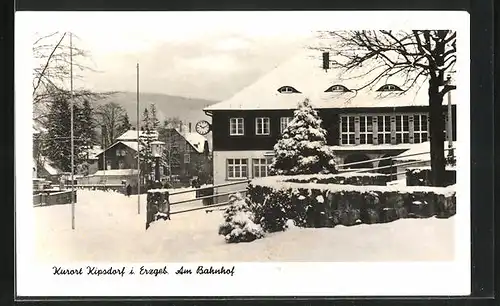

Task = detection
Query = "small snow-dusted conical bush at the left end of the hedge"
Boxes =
[219,193,264,243]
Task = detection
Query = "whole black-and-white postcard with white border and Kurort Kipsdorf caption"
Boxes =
[15,11,470,296]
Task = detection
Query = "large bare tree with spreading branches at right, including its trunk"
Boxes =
[314,30,457,186]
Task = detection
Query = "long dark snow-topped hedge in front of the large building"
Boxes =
[247,176,456,232]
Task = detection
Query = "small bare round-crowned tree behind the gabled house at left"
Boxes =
[94,102,127,146]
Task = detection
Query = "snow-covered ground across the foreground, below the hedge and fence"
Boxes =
[34,190,454,263]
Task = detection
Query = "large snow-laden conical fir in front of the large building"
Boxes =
[269,99,336,175]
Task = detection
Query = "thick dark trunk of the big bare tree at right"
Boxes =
[429,79,446,187]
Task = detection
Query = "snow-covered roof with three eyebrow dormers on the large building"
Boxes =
[204,51,458,111]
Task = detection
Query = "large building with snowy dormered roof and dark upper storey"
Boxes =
[204,50,456,192]
